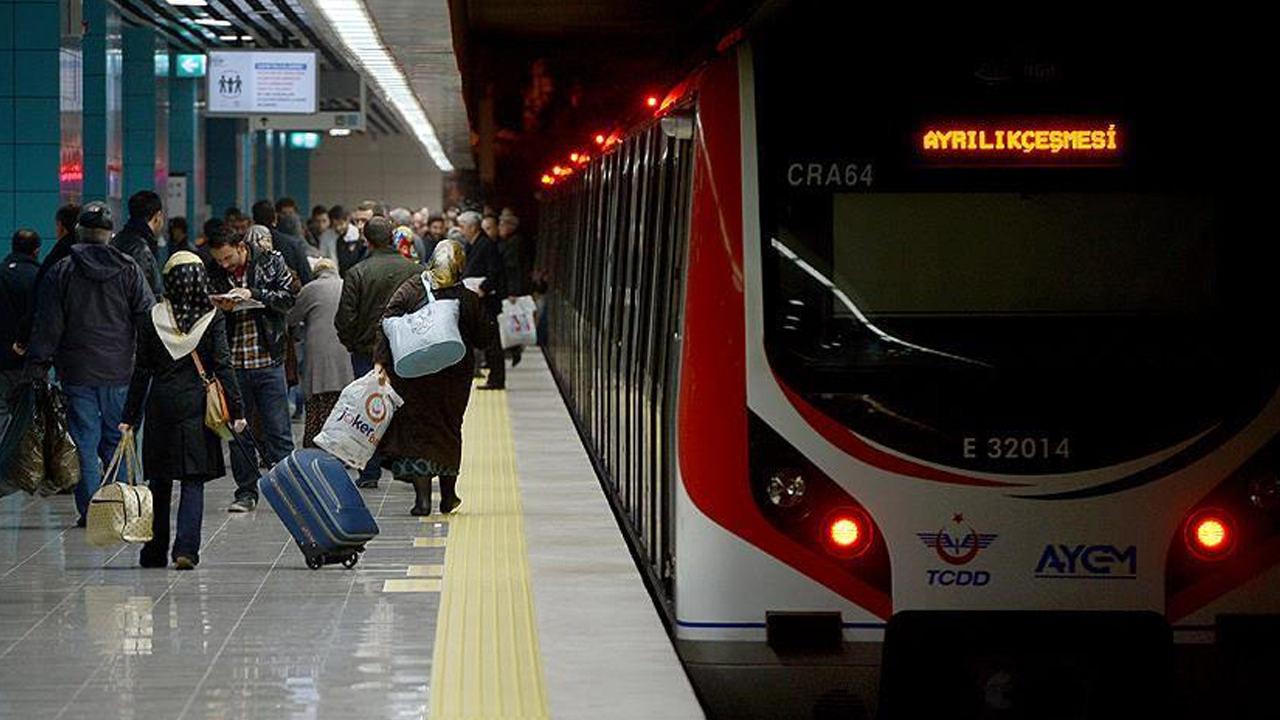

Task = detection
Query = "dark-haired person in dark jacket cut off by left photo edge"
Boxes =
[0,228,40,428]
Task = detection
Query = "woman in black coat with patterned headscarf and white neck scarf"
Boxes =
[120,251,244,570]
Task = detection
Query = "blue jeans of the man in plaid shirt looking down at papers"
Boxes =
[232,365,293,501]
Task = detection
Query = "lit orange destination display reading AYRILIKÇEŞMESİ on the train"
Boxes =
[916,120,1124,167]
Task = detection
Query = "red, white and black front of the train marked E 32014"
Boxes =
[677,13,1280,717]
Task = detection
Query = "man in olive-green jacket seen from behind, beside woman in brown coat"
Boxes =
[333,217,422,488]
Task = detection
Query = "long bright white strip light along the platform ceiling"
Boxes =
[316,0,453,173]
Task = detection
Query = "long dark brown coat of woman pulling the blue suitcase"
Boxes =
[374,274,486,469]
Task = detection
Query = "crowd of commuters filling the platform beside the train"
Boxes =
[0,191,530,569]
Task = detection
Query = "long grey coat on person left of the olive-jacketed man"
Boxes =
[289,270,353,395]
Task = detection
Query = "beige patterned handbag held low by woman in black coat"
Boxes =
[84,430,154,547]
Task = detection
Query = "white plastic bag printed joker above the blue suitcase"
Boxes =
[314,370,404,468]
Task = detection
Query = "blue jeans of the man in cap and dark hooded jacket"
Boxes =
[63,384,129,518]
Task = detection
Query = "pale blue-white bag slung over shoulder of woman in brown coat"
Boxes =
[383,274,467,378]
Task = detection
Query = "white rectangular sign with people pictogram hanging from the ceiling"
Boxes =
[206,50,319,115]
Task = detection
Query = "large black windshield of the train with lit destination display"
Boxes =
[753,17,1280,474]
